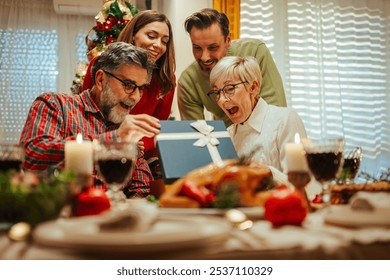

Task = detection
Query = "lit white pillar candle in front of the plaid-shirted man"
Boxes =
[65,133,93,174]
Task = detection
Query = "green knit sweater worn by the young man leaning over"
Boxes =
[177,39,287,126]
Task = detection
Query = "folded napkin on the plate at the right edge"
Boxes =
[350,191,390,213]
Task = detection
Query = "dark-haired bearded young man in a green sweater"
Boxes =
[177,9,287,126]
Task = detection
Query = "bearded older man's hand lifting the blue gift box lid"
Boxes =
[118,114,160,142]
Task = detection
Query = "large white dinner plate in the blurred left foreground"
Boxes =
[33,215,231,254]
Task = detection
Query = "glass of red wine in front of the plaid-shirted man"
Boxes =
[94,139,138,207]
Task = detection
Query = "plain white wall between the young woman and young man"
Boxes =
[155,0,212,119]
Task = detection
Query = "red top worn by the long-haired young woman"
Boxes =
[82,57,175,159]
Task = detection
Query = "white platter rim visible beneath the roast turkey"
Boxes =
[159,207,264,219]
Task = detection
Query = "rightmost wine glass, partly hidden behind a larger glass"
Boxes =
[337,146,362,185]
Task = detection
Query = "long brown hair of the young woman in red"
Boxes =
[117,10,176,97]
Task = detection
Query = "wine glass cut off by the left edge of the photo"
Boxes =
[0,143,24,172]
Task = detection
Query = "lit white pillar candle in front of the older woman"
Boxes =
[284,133,309,172]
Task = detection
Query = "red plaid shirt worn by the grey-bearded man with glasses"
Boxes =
[20,90,153,197]
